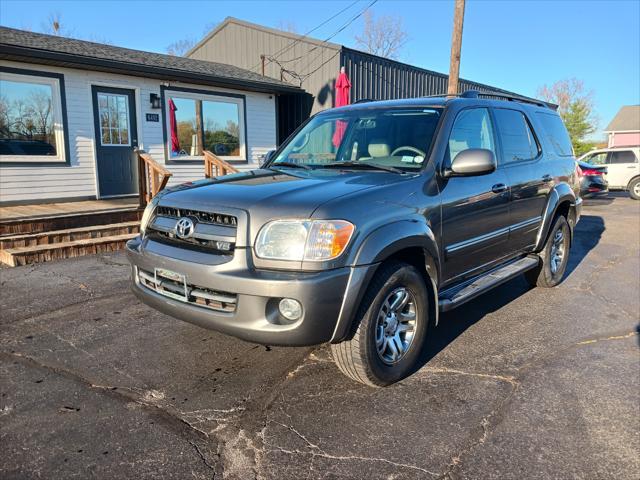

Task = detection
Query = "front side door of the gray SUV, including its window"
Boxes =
[440,108,509,286]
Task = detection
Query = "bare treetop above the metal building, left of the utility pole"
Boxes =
[355,11,409,59]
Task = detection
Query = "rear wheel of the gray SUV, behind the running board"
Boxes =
[524,215,571,288]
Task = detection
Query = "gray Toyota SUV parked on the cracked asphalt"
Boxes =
[127,92,582,386]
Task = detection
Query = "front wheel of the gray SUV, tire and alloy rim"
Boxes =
[331,262,429,387]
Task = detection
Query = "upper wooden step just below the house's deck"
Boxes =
[0,221,140,250]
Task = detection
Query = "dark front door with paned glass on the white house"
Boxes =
[91,86,138,197]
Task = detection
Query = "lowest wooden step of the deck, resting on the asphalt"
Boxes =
[0,233,137,267]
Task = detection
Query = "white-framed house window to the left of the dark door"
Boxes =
[0,72,66,163]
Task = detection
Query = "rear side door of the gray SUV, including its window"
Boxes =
[493,108,553,252]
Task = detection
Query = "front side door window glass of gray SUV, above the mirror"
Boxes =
[449,108,495,164]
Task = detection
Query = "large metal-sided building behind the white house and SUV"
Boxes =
[187,17,518,140]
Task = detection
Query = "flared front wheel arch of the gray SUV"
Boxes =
[331,220,440,343]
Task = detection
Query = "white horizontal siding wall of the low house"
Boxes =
[0,61,276,202]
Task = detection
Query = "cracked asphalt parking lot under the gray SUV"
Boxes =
[0,194,640,479]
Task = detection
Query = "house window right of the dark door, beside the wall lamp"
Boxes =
[165,91,246,161]
